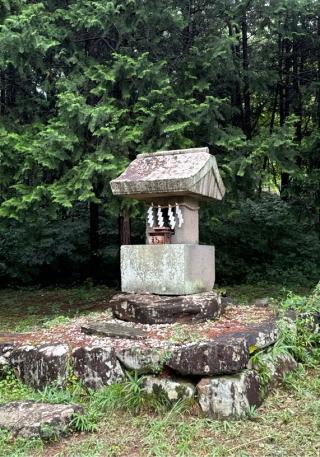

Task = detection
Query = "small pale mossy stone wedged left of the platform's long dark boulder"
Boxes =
[117,347,170,374]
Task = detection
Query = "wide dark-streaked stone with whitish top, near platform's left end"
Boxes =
[9,344,69,389]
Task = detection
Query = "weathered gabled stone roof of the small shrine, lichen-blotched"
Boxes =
[110,148,225,200]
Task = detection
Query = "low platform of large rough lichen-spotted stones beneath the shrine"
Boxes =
[0,307,296,416]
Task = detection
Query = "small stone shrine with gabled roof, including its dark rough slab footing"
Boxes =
[111,148,225,323]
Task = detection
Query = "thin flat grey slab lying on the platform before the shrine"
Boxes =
[81,322,146,340]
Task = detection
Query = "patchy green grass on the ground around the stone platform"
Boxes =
[0,285,320,457]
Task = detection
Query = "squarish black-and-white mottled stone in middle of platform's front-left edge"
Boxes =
[72,346,124,389]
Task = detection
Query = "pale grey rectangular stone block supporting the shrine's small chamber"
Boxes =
[121,244,215,295]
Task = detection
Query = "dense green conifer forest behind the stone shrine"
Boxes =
[0,0,320,286]
